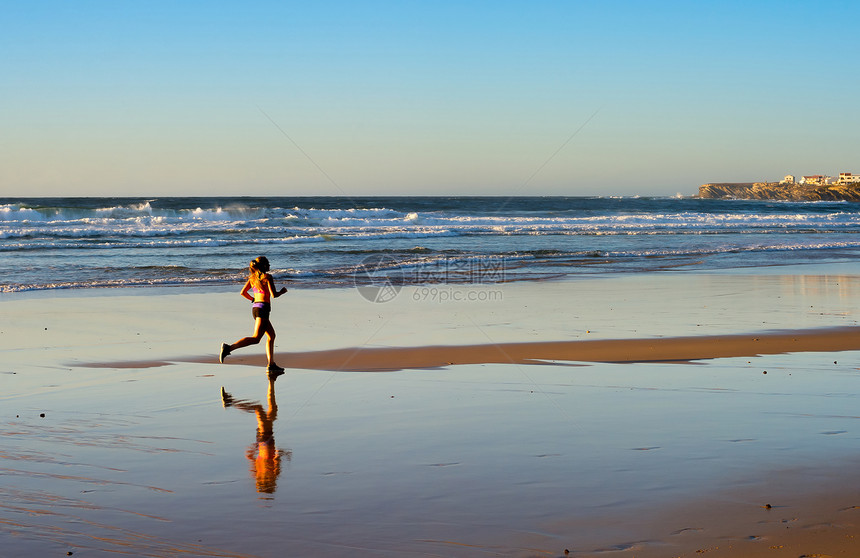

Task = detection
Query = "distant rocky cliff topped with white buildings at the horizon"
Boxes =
[699,182,860,201]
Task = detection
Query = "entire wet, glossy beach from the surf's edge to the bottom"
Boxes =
[0,265,860,558]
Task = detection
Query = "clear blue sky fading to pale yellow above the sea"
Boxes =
[0,0,860,196]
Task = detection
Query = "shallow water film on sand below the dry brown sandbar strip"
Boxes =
[5,352,860,556]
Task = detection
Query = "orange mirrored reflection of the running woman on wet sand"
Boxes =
[221,374,293,494]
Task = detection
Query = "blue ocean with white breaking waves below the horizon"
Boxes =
[0,197,860,293]
